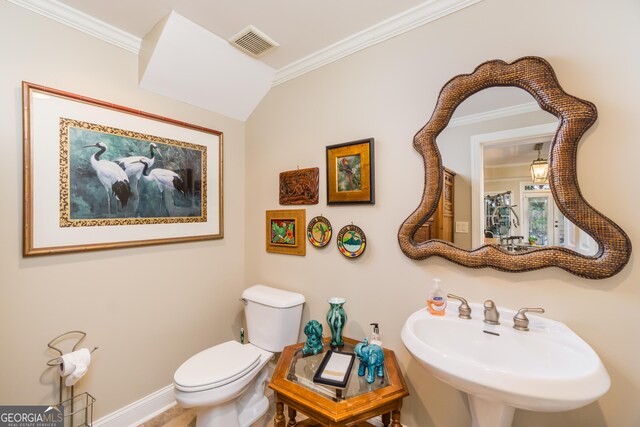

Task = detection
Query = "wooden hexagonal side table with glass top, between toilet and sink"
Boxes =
[269,337,409,427]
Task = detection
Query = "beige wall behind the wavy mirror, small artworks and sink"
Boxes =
[246,0,640,427]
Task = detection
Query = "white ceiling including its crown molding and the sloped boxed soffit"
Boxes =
[9,0,482,121]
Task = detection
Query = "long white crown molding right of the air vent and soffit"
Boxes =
[273,0,482,86]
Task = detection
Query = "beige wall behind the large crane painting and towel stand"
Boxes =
[0,0,245,419]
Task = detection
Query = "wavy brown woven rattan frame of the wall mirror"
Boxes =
[398,57,631,279]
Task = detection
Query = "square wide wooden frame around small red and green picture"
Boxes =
[266,209,306,256]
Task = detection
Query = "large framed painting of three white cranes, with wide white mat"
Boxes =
[23,82,223,255]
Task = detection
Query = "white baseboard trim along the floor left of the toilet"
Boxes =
[93,384,176,427]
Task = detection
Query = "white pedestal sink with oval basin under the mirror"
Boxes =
[402,304,611,427]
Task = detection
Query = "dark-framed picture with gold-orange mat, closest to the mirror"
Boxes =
[327,138,375,205]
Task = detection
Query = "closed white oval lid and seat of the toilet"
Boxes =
[173,341,260,391]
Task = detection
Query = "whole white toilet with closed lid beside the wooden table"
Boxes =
[173,285,304,427]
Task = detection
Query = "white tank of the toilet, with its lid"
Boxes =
[242,285,304,353]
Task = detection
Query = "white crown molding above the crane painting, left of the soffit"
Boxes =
[8,0,142,55]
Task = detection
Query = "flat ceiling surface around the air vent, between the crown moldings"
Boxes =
[51,0,440,70]
